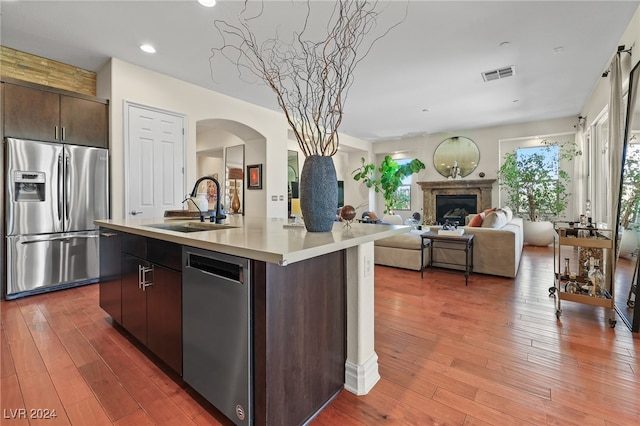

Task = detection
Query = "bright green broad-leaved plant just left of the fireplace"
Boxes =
[352,155,426,215]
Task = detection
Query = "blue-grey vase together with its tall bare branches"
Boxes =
[212,0,398,232]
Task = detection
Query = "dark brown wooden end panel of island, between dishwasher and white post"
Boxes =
[251,251,347,426]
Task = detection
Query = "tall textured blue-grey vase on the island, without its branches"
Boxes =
[300,155,338,232]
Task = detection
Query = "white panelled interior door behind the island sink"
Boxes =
[125,104,185,218]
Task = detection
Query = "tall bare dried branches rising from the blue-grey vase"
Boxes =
[212,0,402,157]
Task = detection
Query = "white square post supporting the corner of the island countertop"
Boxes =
[344,242,380,395]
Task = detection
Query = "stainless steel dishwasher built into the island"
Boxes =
[182,247,253,425]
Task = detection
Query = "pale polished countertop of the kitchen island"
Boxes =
[95,215,410,266]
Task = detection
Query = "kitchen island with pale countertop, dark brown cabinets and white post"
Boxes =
[96,215,408,424]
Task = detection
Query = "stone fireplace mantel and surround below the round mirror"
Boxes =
[418,179,496,224]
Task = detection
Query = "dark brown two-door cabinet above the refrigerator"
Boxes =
[4,83,109,148]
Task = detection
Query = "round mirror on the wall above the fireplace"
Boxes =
[433,136,480,179]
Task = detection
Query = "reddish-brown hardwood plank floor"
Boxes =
[0,247,640,425]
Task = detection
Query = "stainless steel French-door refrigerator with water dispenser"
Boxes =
[5,138,109,299]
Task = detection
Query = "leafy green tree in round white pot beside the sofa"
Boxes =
[498,140,582,246]
